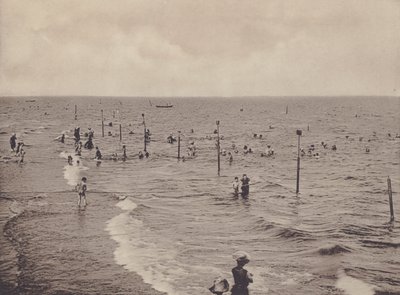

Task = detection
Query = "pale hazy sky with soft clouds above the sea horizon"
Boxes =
[0,0,400,96]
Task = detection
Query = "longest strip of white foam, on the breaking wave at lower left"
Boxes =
[106,198,184,295]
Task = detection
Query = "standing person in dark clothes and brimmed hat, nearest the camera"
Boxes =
[231,251,253,295]
